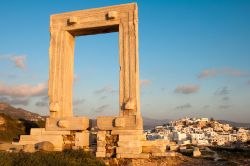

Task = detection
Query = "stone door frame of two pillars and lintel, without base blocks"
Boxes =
[48,3,142,128]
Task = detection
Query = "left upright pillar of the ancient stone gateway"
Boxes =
[48,29,74,118]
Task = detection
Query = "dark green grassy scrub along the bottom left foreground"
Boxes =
[0,150,105,166]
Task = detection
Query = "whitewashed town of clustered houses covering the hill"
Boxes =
[145,118,250,155]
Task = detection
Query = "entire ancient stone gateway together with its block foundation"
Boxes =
[19,3,174,158]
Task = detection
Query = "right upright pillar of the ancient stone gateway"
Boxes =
[119,5,140,119]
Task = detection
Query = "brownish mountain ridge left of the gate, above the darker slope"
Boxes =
[0,102,45,121]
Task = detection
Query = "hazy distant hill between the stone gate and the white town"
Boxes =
[143,117,171,130]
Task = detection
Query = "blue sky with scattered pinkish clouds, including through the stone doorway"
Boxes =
[0,0,250,122]
